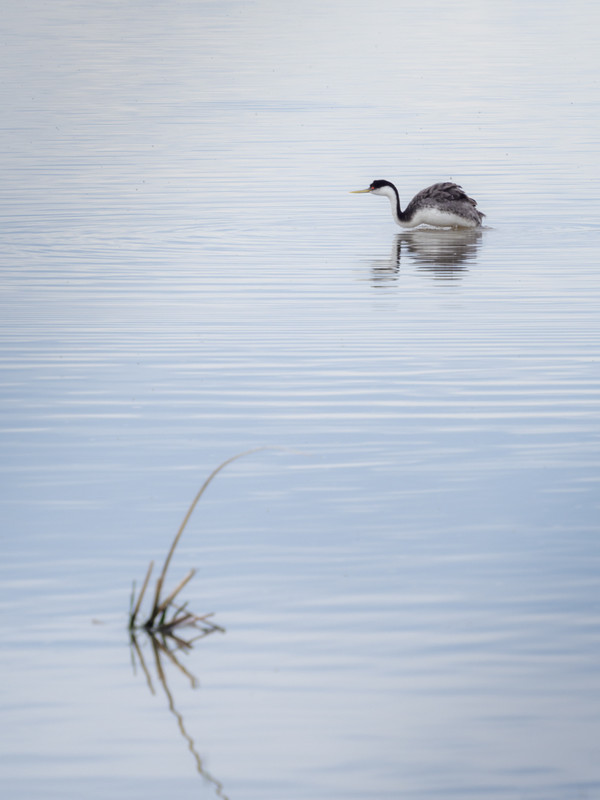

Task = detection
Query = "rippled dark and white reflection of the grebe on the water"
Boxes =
[371,228,482,286]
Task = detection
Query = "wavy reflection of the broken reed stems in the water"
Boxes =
[131,625,229,800]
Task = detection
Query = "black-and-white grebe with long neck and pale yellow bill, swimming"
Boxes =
[350,181,485,228]
